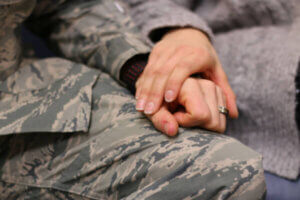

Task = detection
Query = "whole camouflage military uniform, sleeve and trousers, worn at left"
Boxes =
[0,0,265,200]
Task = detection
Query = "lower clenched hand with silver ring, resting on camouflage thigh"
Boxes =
[147,78,226,136]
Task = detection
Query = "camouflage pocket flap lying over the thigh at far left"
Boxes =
[0,59,99,135]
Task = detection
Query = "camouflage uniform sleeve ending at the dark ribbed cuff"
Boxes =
[27,0,150,81]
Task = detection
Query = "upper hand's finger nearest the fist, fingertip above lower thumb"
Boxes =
[165,47,214,102]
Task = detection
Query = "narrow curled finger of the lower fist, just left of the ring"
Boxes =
[198,79,222,132]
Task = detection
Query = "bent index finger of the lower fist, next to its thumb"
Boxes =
[174,80,211,127]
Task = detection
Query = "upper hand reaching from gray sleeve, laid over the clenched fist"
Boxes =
[136,28,238,118]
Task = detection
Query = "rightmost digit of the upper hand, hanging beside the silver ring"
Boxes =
[210,64,239,118]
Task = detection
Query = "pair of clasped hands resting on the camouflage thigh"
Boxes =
[136,28,238,136]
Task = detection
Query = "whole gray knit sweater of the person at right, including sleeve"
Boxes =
[126,0,300,179]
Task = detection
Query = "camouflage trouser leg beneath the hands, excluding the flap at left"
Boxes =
[0,65,265,200]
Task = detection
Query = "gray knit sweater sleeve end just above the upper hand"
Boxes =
[126,0,213,42]
